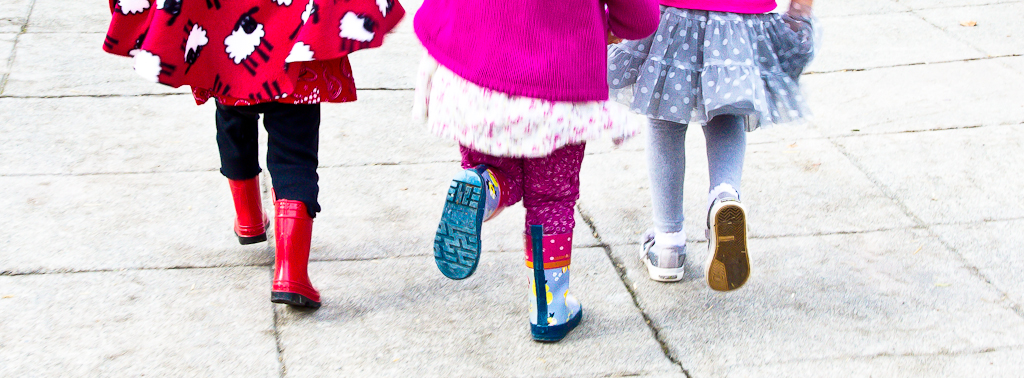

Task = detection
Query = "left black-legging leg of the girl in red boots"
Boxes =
[216,102,260,180]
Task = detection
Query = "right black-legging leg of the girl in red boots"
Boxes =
[256,102,321,216]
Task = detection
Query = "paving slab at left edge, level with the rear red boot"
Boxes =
[0,172,273,275]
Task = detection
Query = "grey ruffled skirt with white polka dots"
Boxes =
[608,6,815,131]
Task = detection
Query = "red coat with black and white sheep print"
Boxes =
[103,0,406,104]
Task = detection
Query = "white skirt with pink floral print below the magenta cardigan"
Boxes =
[413,55,647,158]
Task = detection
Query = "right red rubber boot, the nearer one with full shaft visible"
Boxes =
[270,200,319,309]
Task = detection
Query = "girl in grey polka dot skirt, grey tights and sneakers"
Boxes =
[608,0,813,291]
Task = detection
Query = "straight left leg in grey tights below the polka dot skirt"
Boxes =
[647,119,686,234]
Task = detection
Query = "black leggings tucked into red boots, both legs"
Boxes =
[217,102,321,216]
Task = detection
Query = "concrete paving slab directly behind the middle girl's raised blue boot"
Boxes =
[312,162,598,260]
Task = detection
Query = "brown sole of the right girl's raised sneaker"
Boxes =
[708,203,751,291]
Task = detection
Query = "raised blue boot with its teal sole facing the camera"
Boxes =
[434,165,511,280]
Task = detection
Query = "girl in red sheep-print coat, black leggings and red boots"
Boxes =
[103,0,404,309]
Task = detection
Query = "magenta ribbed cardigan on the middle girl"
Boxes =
[414,0,659,101]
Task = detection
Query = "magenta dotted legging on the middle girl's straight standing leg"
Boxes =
[522,143,586,235]
